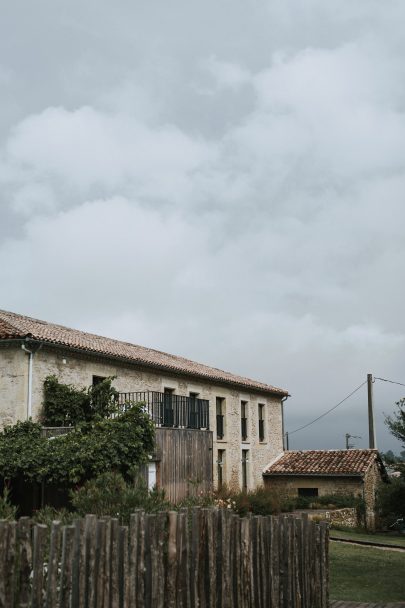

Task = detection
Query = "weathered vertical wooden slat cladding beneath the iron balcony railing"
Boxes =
[156,428,213,502]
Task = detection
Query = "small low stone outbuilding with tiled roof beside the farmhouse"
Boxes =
[263,449,388,529]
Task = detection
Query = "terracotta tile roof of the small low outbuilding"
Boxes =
[263,450,383,476]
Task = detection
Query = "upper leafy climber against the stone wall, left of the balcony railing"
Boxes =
[41,376,118,426]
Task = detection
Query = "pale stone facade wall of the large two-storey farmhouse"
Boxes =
[0,345,282,488]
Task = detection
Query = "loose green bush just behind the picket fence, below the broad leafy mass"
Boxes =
[71,472,172,524]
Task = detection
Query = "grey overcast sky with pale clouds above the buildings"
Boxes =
[0,0,405,452]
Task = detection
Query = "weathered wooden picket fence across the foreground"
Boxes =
[0,508,328,608]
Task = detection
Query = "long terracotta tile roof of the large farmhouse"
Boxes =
[0,310,288,396]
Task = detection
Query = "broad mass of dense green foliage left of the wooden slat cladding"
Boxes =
[0,404,154,485]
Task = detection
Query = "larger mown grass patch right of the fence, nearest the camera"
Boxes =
[330,542,405,602]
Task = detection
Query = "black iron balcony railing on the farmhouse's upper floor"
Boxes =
[118,391,210,430]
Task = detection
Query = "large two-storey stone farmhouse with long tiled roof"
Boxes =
[0,311,288,490]
